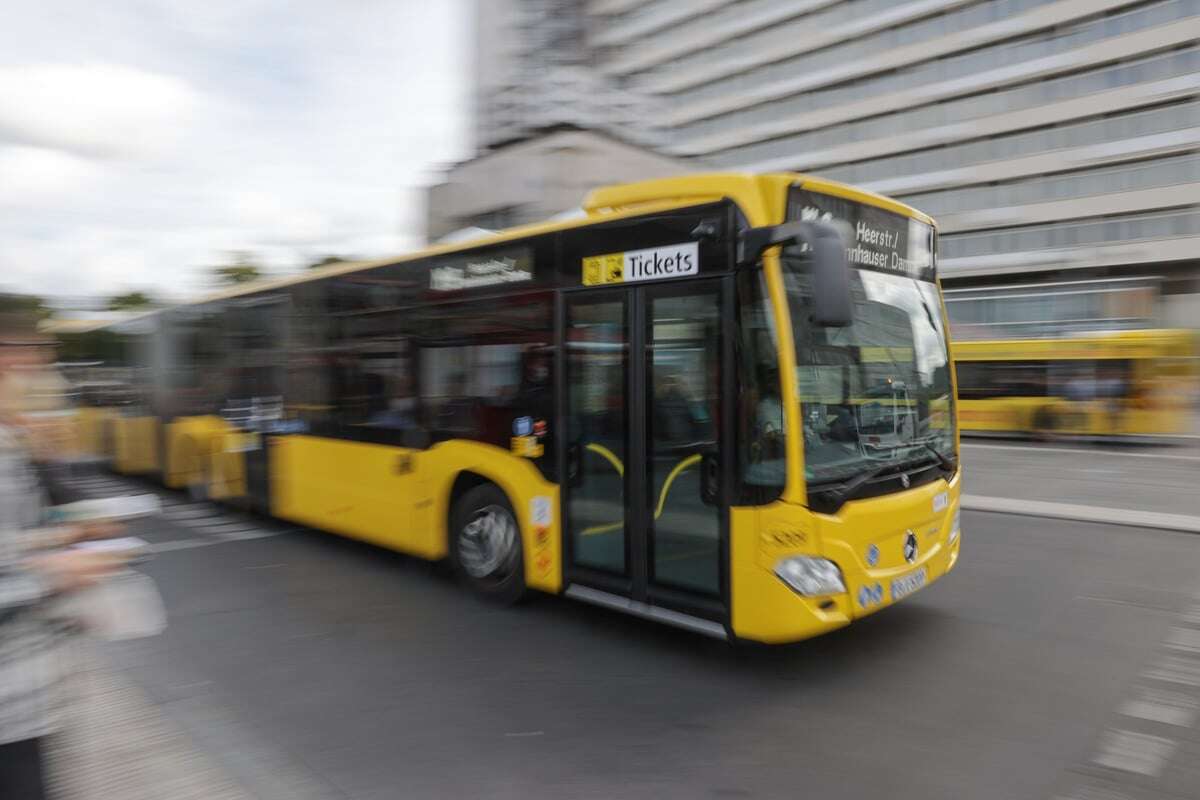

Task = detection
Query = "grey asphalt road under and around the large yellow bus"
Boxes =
[68,445,1200,800]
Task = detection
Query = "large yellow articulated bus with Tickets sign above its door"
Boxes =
[70,174,961,643]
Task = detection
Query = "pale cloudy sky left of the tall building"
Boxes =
[0,0,470,300]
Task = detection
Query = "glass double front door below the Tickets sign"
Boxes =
[564,278,732,633]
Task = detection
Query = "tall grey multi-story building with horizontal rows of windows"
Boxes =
[444,0,1200,324]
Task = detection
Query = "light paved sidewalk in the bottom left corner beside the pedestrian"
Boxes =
[48,643,254,800]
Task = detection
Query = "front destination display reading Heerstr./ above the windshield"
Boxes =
[787,190,934,281]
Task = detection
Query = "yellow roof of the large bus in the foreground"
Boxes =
[82,173,934,330]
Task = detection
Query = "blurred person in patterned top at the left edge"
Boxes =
[0,312,120,800]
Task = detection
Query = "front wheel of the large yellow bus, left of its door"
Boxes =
[450,483,526,604]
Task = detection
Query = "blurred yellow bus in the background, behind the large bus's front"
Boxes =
[954,330,1196,437]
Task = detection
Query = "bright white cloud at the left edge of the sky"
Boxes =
[0,64,200,158]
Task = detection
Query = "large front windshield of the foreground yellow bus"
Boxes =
[782,198,954,489]
